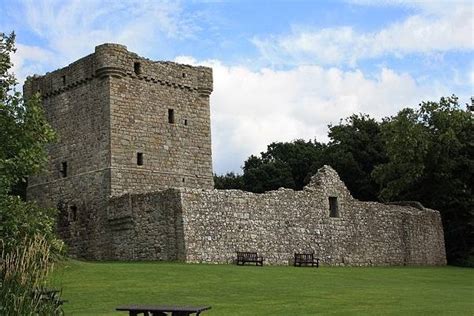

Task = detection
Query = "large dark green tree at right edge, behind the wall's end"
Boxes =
[373,96,474,264]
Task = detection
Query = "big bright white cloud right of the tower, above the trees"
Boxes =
[176,57,449,173]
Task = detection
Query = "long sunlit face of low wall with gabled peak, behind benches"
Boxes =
[182,167,446,265]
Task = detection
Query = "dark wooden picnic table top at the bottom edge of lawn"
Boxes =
[116,305,211,316]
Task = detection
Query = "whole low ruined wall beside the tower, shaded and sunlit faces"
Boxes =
[105,166,446,266]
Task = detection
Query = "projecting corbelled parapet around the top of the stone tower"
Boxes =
[23,44,213,99]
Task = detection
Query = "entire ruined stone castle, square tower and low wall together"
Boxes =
[24,44,446,265]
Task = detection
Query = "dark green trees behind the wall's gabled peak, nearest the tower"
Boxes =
[215,115,386,200]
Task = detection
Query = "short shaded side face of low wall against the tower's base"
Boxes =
[107,189,185,260]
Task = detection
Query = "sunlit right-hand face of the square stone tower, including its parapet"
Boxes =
[96,46,214,196]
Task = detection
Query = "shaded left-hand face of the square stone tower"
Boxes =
[24,55,110,259]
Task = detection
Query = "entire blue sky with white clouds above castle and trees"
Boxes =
[0,0,474,174]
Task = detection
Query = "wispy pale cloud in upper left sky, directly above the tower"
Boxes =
[10,0,197,84]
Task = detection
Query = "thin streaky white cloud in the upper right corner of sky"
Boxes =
[252,2,474,66]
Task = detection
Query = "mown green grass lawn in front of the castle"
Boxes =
[52,261,474,315]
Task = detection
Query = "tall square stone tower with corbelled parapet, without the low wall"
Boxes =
[24,44,213,258]
